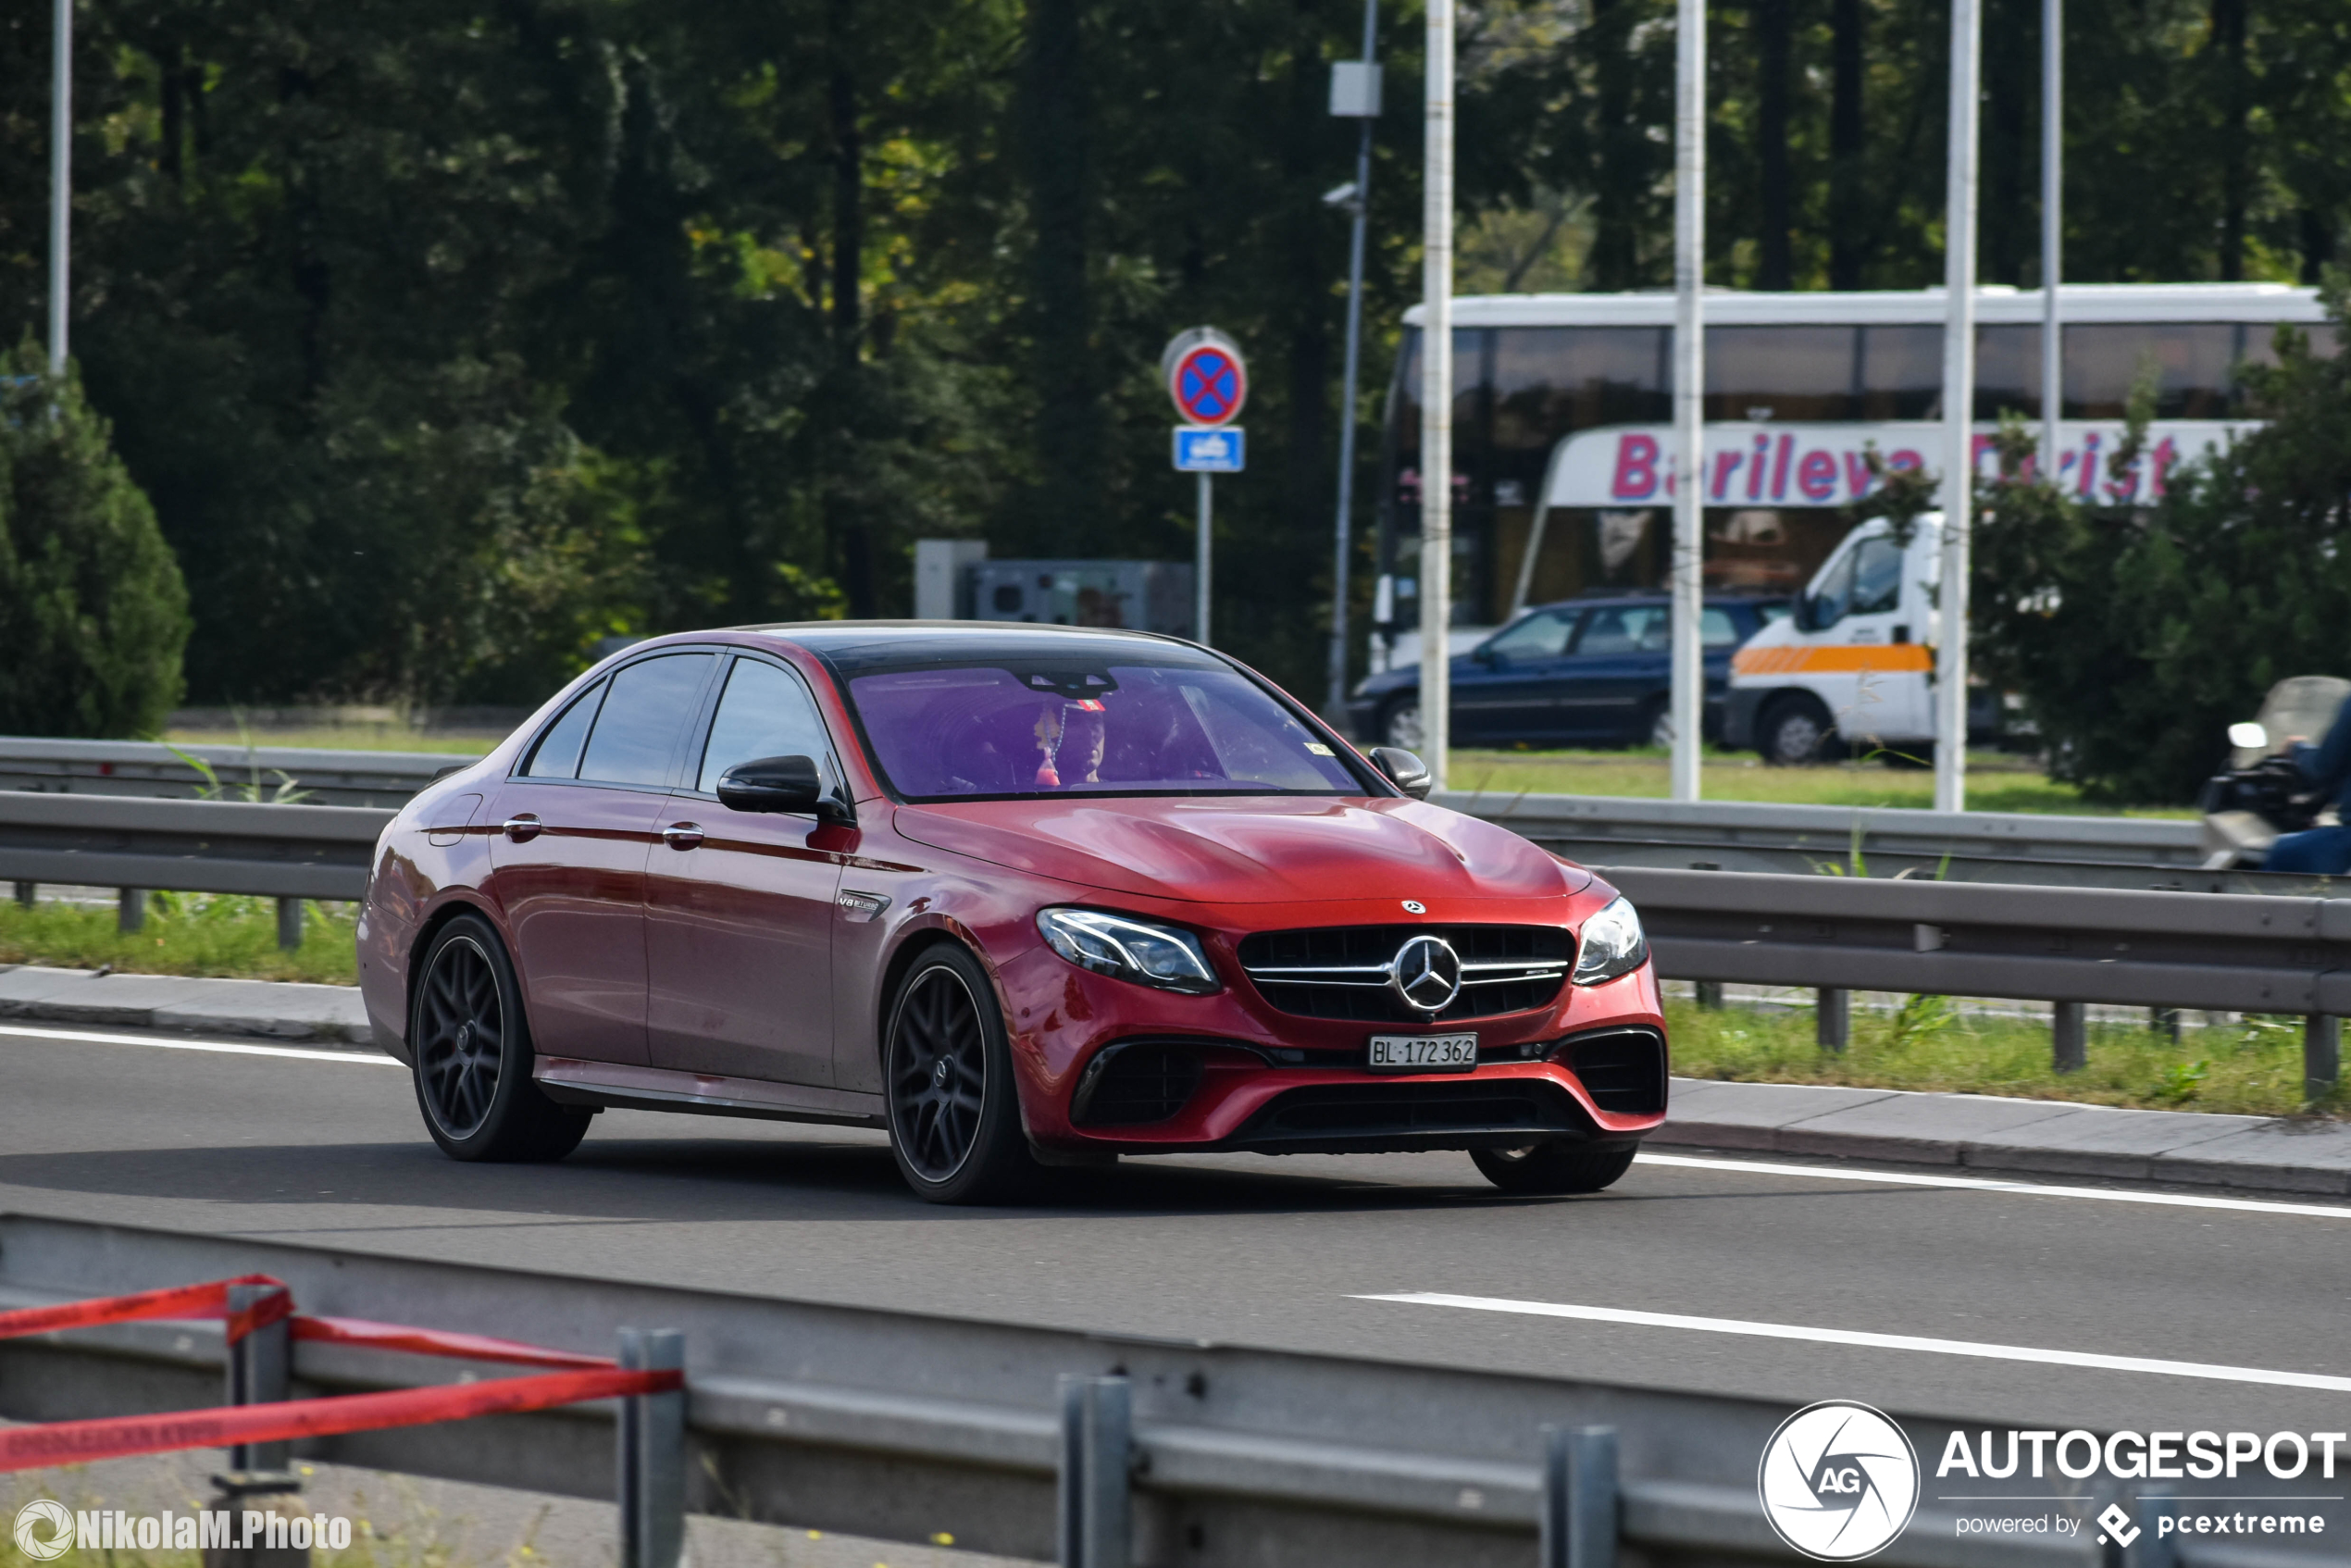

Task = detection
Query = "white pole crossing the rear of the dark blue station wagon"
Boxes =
[1673,0,1707,800]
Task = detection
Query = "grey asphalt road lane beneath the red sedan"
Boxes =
[0,1025,2351,1448]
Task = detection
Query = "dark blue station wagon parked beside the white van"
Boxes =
[1347,595,1786,750]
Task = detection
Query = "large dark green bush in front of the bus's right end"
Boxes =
[1971,278,2351,802]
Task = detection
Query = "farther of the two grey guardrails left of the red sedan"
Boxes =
[0,736,475,806]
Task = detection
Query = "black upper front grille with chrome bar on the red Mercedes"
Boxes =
[1241,927,1575,1023]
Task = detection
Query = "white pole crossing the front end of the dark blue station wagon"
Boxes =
[1420,0,1453,790]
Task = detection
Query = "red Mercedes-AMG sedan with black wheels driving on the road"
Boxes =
[360,620,1667,1201]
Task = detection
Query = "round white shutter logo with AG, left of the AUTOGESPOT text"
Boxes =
[1756,1399,1919,1563]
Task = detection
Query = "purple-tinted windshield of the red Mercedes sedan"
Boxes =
[846,656,1368,802]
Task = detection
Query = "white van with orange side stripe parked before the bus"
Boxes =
[1723,513,1998,764]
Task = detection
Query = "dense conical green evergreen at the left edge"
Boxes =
[0,339,188,736]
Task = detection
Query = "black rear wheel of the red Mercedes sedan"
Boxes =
[409,915,592,1162]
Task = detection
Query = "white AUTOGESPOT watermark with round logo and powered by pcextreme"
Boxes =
[1756,1399,2351,1563]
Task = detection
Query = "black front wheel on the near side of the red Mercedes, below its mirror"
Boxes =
[882,942,1037,1203]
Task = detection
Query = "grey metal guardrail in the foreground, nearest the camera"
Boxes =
[0,1215,2320,1568]
